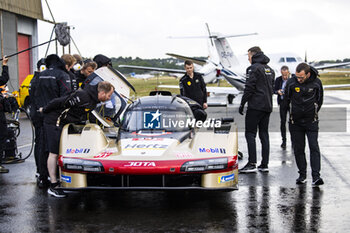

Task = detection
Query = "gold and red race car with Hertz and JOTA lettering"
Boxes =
[59,66,238,190]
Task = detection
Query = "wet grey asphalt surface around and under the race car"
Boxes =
[0,91,350,232]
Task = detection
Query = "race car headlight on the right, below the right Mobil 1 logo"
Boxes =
[180,158,228,172]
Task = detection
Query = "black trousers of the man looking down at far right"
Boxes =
[289,121,321,180]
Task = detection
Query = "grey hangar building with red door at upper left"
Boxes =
[0,0,43,91]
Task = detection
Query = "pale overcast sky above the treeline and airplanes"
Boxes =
[39,0,350,61]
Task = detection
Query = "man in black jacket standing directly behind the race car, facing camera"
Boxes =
[179,60,208,109]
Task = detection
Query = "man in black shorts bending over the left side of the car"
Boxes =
[40,81,114,197]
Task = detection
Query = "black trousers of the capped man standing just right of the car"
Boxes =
[245,109,271,165]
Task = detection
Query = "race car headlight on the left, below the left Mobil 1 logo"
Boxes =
[63,158,104,172]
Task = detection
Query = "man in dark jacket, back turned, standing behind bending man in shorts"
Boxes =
[31,54,71,187]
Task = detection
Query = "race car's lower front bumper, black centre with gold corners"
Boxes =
[61,167,238,191]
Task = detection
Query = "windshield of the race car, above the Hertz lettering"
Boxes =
[122,109,195,132]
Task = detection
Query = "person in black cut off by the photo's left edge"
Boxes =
[0,57,9,173]
